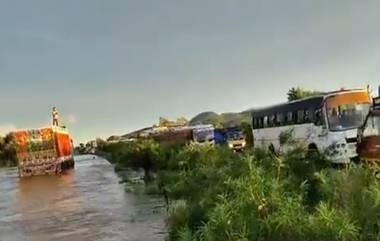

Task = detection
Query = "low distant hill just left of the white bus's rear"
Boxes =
[190,111,251,127]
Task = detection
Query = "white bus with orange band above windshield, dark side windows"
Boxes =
[252,89,371,163]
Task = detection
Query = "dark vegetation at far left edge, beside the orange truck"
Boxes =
[0,134,17,167]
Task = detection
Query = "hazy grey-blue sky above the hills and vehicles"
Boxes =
[0,0,380,143]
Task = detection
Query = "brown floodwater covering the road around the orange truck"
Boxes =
[0,156,165,241]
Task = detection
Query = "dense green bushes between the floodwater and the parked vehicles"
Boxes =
[100,139,380,241]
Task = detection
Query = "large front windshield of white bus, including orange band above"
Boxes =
[326,92,370,131]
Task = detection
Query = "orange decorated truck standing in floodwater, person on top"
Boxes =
[13,126,74,177]
